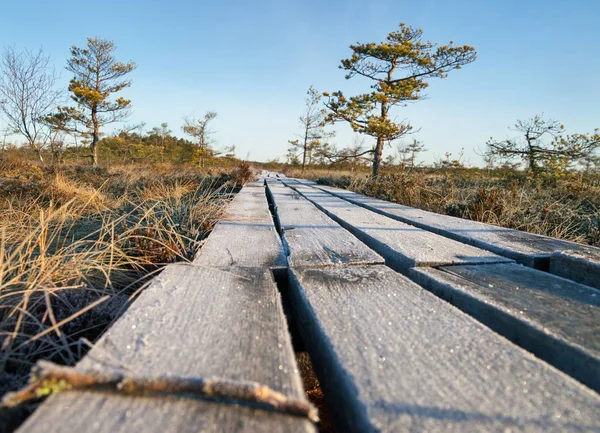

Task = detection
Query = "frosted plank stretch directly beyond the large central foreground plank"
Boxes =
[268,182,383,267]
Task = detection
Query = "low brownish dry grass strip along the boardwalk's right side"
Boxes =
[287,169,600,246]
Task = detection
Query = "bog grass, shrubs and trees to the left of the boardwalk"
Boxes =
[0,38,253,431]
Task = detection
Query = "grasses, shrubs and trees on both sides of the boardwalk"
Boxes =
[0,19,600,430]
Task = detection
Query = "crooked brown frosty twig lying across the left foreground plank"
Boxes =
[2,361,319,422]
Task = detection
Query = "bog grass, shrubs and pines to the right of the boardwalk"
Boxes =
[287,23,600,246]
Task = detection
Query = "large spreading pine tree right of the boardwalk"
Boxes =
[324,23,477,177]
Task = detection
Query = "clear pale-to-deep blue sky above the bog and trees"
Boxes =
[0,0,600,165]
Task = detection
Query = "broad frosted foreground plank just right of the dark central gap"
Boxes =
[290,266,600,432]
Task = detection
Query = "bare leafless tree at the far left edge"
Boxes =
[0,48,61,162]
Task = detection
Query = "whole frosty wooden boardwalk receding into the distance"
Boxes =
[19,172,600,433]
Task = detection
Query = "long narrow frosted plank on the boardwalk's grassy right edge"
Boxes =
[316,185,582,270]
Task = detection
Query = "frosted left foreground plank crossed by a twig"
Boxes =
[19,265,314,433]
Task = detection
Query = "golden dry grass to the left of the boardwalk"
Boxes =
[0,156,244,430]
